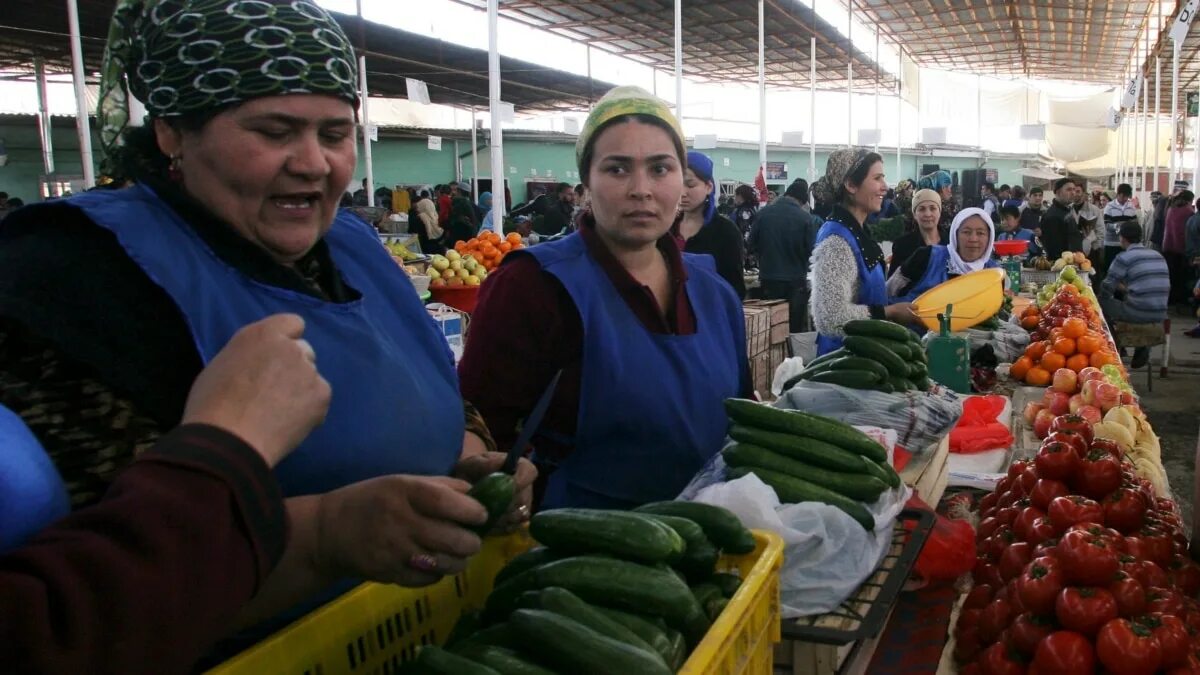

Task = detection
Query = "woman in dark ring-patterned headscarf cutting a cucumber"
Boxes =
[0,0,534,648]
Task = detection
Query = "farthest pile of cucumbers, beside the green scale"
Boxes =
[786,318,932,393]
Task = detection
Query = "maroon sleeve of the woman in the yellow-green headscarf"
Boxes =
[458,255,583,450]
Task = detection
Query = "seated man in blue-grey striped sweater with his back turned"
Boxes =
[1100,222,1171,368]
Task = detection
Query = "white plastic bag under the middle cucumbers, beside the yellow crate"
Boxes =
[680,454,912,619]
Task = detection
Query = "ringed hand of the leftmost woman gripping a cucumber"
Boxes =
[313,476,487,586]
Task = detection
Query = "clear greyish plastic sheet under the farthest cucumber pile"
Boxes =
[774,381,962,454]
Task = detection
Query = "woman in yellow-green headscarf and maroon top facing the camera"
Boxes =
[460,86,749,508]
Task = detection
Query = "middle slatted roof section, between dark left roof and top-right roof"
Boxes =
[456,0,895,91]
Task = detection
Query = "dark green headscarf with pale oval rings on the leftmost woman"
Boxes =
[100,0,359,166]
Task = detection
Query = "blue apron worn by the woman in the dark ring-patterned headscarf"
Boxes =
[71,185,464,496]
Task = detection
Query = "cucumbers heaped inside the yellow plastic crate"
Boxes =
[412,502,755,675]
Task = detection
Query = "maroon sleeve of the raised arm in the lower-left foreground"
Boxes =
[0,425,287,673]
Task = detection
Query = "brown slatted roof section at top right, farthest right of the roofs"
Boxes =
[854,0,1158,85]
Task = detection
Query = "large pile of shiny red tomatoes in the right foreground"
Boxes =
[954,414,1200,675]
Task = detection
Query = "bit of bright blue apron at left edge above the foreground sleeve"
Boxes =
[0,406,71,552]
